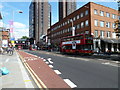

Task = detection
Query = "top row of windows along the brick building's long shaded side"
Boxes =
[51,10,88,31]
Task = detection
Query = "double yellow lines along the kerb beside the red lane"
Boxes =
[18,53,48,90]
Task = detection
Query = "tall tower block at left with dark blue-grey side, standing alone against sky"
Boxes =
[29,0,51,44]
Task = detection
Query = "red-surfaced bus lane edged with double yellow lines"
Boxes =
[18,51,70,89]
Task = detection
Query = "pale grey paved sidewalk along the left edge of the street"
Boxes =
[0,51,36,89]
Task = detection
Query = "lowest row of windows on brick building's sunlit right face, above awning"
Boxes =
[94,30,114,38]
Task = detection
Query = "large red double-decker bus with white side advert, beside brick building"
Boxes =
[60,34,93,54]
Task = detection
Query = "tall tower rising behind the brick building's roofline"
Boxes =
[59,0,76,21]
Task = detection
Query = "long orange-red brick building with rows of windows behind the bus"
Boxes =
[48,2,120,52]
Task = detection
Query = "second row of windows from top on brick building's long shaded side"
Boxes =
[52,20,89,37]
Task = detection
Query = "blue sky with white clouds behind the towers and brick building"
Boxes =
[0,0,117,39]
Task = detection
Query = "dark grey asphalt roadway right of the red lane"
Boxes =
[26,51,118,88]
